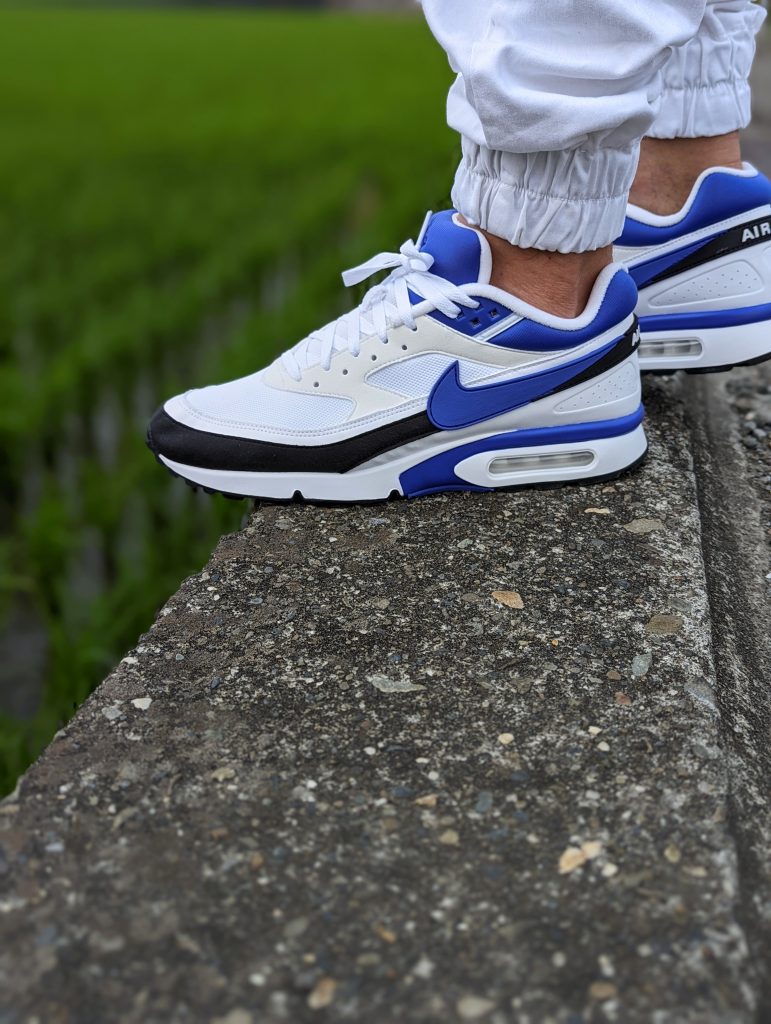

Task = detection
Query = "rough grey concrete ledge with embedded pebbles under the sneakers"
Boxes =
[0,378,771,1024]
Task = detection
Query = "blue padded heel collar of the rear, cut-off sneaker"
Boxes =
[616,171,771,246]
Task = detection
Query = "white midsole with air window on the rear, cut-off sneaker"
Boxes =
[640,321,771,373]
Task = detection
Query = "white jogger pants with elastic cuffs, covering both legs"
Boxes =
[422,0,765,252]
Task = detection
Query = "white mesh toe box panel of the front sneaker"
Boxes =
[180,371,353,431]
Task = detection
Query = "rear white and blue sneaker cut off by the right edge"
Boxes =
[615,164,771,372]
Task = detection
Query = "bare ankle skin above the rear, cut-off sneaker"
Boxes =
[629,131,741,214]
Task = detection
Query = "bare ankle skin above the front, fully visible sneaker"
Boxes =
[461,216,613,317]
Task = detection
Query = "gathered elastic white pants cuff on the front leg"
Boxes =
[453,138,637,253]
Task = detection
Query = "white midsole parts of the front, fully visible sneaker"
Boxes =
[160,425,646,502]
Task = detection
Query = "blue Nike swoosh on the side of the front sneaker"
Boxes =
[426,338,620,430]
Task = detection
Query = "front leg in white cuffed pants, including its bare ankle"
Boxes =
[423,0,703,315]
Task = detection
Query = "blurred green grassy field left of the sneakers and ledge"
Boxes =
[0,10,457,792]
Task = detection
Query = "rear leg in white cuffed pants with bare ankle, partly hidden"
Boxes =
[630,0,765,214]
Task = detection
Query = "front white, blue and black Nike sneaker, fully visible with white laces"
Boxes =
[148,211,646,502]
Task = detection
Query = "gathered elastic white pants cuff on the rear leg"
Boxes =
[648,79,749,138]
